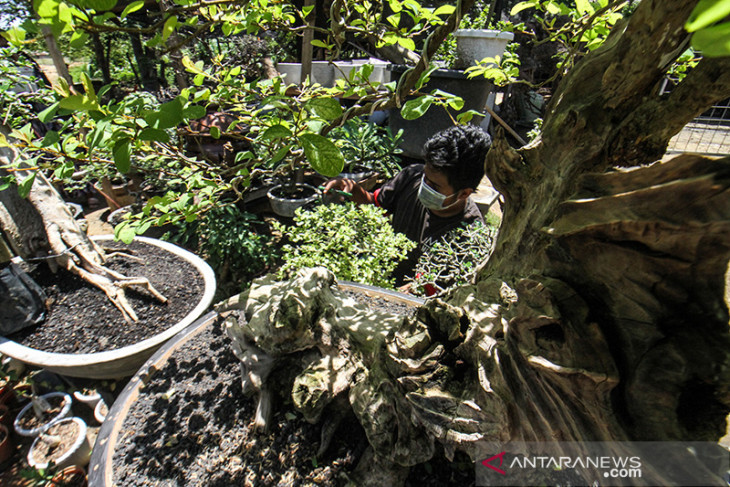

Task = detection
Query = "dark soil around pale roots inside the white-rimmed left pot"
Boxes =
[8,240,203,353]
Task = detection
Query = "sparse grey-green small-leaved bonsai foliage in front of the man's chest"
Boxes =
[410,222,497,296]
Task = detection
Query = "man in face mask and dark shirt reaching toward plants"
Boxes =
[325,125,491,284]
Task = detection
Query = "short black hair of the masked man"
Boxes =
[423,125,492,191]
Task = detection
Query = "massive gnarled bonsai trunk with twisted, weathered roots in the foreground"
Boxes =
[222,0,730,484]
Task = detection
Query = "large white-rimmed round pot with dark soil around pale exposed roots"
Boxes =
[0,235,216,379]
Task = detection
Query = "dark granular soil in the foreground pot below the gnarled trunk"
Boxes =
[112,293,474,487]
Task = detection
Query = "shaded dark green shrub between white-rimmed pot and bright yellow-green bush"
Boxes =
[164,204,278,296]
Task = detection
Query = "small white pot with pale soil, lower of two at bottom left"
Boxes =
[28,417,91,469]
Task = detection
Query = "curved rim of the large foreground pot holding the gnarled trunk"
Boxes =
[88,281,426,487]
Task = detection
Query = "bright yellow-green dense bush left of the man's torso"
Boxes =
[275,202,416,288]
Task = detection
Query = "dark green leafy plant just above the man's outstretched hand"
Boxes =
[329,118,403,178]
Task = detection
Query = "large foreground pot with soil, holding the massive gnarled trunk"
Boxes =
[89,283,436,487]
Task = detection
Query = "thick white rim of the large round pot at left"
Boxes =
[0,235,216,379]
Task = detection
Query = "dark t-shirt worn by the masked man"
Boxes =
[375,164,484,285]
